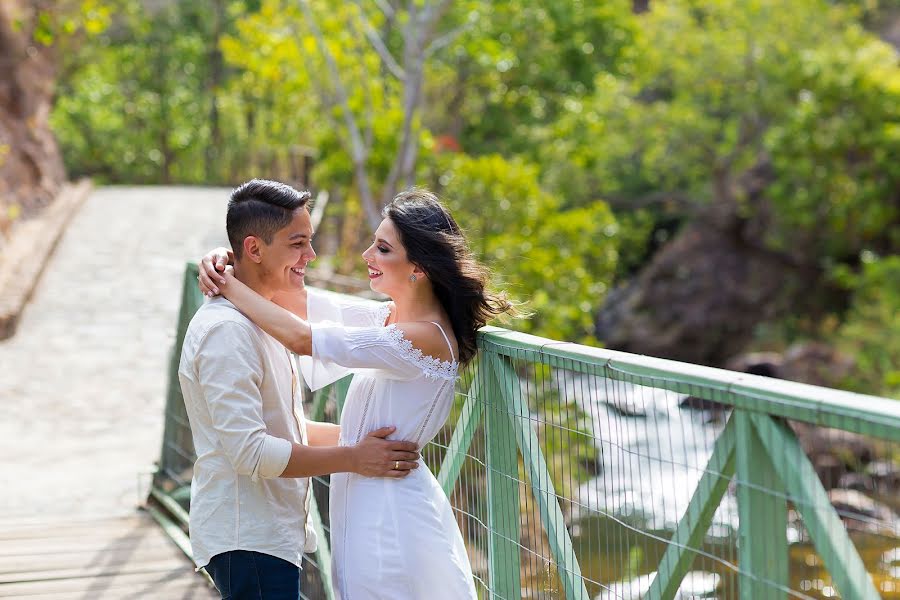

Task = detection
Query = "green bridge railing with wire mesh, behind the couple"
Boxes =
[151,266,900,600]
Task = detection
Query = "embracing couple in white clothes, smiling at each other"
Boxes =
[179,180,512,600]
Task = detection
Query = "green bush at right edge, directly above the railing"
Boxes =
[833,254,900,399]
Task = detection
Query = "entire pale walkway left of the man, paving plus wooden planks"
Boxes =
[0,187,228,600]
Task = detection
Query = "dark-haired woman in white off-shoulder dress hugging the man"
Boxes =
[204,190,512,600]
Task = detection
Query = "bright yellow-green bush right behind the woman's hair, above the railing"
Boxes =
[435,154,618,343]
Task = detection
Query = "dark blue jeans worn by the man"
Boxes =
[206,550,300,600]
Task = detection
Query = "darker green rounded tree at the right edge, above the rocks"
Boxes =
[766,27,900,257]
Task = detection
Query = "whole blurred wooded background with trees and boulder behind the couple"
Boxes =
[15,0,900,395]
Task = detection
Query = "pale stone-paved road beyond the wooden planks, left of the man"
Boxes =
[0,187,228,518]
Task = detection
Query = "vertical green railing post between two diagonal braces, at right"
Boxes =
[732,410,790,600]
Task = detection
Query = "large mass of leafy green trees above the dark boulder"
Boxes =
[541,0,900,296]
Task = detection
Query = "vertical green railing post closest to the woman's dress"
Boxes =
[486,350,522,600]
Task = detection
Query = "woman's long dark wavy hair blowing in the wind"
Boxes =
[381,189,515,363]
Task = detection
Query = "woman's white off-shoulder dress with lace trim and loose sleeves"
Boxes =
[301,291,476,600]
